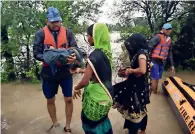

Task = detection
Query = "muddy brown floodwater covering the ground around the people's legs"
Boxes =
[1,72,195,134]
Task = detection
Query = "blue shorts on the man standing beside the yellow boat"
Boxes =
[150,62,164,80]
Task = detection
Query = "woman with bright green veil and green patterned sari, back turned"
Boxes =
[73,23,113,134]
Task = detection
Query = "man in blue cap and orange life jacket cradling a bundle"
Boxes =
[33,7,77,133]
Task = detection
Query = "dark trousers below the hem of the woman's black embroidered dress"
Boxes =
[124,115,148,134]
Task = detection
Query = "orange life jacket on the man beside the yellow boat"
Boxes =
[152,34,171,60]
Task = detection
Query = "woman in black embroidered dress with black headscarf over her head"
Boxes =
[113,33,151,134]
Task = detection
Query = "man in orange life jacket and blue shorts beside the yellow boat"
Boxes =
[149,23,175,94]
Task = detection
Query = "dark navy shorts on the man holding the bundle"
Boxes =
[42,76,73,99]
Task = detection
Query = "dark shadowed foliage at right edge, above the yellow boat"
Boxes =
[174,5,195,69]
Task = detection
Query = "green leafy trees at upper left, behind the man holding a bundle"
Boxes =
[1,1,103,81]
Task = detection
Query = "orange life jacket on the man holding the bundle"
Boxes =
[43,26,68,66]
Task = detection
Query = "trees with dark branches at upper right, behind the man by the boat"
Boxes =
[114,0,195,69]
